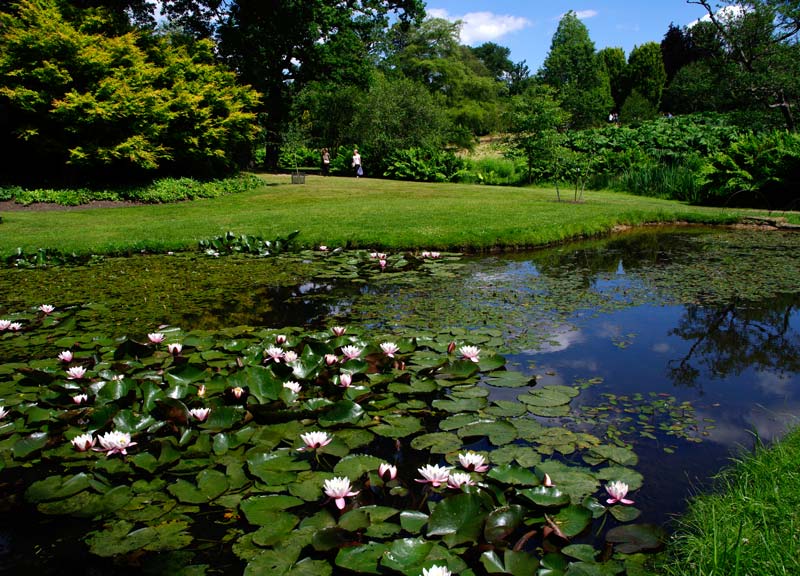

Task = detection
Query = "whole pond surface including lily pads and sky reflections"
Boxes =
[0,228,800,574]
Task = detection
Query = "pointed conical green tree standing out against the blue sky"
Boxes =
[539,11,614,128]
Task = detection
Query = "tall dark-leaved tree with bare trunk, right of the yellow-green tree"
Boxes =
[164,0,424,165]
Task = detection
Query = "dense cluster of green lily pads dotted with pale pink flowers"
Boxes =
[0,307,662,576]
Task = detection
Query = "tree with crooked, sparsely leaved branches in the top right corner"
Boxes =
[687,0,800,130]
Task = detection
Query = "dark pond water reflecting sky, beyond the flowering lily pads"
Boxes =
[0,228,800,572]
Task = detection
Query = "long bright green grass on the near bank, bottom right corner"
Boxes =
[659,429,800,576]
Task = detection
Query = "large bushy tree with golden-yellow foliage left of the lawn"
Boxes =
[0,0,258,180]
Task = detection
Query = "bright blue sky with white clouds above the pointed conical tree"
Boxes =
[427,0,705,73]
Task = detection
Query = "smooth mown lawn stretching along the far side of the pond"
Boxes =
[0,175,768,256]
